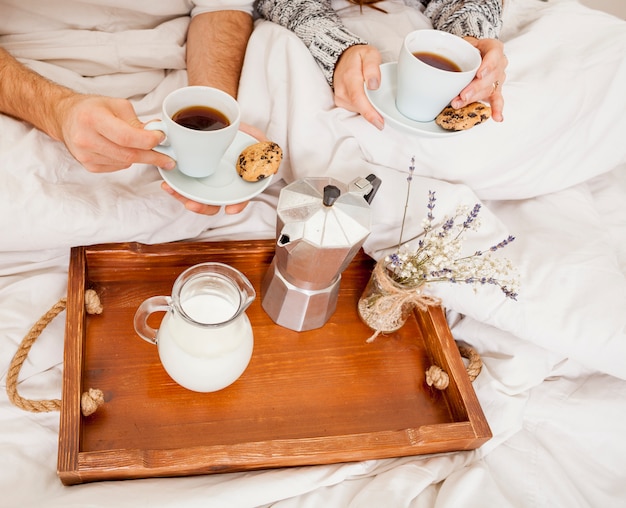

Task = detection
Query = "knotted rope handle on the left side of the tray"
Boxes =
[7,289,104,416]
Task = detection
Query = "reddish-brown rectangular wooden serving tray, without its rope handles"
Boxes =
[58,241,491,485]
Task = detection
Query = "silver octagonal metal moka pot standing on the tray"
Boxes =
[261,175,380,331]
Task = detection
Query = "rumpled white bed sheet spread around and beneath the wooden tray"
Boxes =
[0,0,626,508]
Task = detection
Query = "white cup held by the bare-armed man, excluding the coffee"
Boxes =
[144,86,241,178]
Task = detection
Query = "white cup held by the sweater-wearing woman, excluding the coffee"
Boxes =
[396,29,481,122]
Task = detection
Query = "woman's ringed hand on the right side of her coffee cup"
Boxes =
[451,37,509,122]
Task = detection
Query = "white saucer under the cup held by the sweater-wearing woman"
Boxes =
[365,62,463,137]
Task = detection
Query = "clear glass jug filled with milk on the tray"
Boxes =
[135,262,256,392]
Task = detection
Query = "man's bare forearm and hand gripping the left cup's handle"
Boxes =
[0,48,174,172]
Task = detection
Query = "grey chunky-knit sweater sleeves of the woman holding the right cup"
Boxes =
[255,0,502,86]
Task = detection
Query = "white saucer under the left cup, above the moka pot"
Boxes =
[159,131,273,206]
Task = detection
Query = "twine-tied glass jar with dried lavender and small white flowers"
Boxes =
[359,159,519,341]
